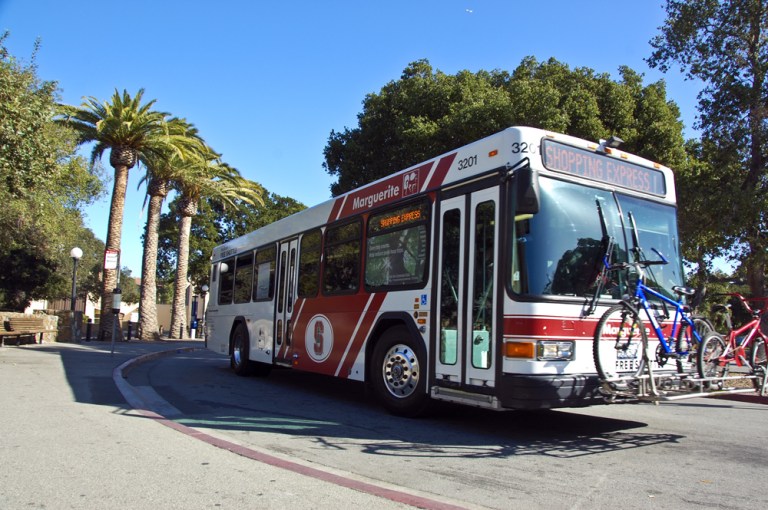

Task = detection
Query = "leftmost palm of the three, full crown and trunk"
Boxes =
[57,89,173,339]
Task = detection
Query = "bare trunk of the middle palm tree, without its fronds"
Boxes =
[139,179,168,340]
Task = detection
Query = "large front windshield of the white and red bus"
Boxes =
[510,176,683,299]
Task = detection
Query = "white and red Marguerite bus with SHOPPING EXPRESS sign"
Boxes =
[205,127,683,416]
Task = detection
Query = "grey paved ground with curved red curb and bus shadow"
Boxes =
[0,343,768,509]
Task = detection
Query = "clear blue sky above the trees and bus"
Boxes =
[0,0,700,276]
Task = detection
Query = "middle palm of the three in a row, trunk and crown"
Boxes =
[138,118,203,340]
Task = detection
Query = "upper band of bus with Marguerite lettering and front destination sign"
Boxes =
[213,127,675,261]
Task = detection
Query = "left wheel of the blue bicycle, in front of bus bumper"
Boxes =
[592,305,648,389]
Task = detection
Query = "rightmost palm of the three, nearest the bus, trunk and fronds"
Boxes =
[170,146,264,338]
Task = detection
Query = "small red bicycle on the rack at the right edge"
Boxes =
[697,292,768,393]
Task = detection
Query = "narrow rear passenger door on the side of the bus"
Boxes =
[275,239,298,365]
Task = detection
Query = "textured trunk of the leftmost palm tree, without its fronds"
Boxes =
[99,165,130,340]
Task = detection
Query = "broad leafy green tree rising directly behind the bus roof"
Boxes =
[324,57,686,195]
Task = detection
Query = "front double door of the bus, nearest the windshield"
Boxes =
[435,187,499,391]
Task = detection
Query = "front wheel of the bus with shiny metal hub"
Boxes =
[369,325,429,417]
